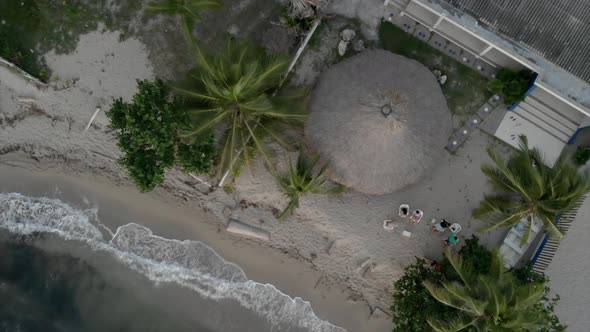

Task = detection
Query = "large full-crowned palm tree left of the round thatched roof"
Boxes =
[177,39,305,176]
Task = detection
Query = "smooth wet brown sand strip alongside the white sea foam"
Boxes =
[0,161,391,332]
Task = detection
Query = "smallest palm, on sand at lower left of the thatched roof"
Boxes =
[275,152,346,219]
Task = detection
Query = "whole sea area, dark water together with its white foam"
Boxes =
[0,193,344,332]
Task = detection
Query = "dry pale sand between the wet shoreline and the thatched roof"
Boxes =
[0,26,508,331]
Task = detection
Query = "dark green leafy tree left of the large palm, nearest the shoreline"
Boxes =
[107,80,215,192]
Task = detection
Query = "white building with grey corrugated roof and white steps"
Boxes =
[385,0,590,164]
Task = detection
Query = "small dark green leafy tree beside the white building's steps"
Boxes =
[488,68,534,105]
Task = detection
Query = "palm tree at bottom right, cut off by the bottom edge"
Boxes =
[424,250,545,332]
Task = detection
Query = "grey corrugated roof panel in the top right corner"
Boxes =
[444,0,590,83]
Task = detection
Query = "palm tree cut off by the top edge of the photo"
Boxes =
[146,0,223,41]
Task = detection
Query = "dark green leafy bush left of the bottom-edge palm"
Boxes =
[391,258,457,332]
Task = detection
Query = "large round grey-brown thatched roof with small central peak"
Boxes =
[305,50,452,194]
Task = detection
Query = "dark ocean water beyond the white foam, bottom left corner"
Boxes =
[0,233,210,332]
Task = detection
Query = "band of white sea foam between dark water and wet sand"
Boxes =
[0,193,345,332]
